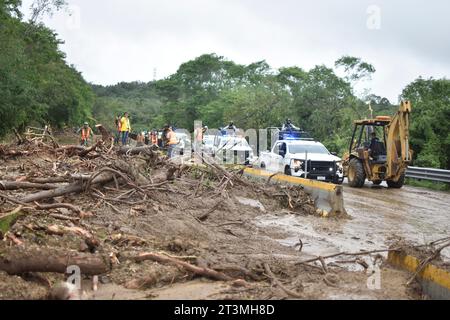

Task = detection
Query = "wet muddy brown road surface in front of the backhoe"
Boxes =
[257,184,450,261]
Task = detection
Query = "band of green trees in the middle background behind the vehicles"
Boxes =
[94,54,396,158]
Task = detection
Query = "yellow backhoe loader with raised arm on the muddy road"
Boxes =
[344,101,413,189]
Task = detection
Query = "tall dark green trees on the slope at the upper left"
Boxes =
[0,0,94,135]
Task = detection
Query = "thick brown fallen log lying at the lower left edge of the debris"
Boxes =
[0,247,110,275]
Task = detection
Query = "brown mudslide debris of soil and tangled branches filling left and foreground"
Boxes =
[0,133,440,299]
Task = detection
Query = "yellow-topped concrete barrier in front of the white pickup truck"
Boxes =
[244,169,347,216]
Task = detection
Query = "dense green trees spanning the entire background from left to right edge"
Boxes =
[0,0,450,169]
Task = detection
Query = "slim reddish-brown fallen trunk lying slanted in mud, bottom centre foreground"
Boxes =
[133,253,233,281]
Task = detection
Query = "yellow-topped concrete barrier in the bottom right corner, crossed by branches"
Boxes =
[388,251,450,300]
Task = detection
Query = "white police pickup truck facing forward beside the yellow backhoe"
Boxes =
[259,140,344,184]
